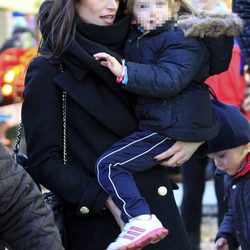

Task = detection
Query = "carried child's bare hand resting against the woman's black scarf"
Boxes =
[94,52,123,77]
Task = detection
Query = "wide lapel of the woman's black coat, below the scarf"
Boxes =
[54,70,137,137]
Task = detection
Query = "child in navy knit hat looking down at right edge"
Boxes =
[208,100,250,250]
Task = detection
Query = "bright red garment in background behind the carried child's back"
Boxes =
[205,44,250,120]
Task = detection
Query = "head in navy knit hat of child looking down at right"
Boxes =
[208,103,250,175]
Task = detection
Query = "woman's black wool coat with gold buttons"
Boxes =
[22,56,190,250]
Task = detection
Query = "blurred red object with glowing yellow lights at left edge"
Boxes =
[0,48,37,105]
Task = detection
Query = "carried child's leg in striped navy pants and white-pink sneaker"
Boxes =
[96,131,173,250]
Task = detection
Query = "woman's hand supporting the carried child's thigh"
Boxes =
[155,141,204,167]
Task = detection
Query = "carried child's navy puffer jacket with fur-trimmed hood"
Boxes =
[124,10,243,141]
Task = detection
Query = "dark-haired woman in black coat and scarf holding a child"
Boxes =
[22,0,206,250]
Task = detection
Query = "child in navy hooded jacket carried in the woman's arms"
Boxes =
[94,0,240,250]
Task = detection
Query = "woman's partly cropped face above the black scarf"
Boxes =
[76,0,119,26]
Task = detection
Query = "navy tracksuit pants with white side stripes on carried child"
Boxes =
[96,131,174,222]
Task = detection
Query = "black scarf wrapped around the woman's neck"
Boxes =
[41,11,130,83]
